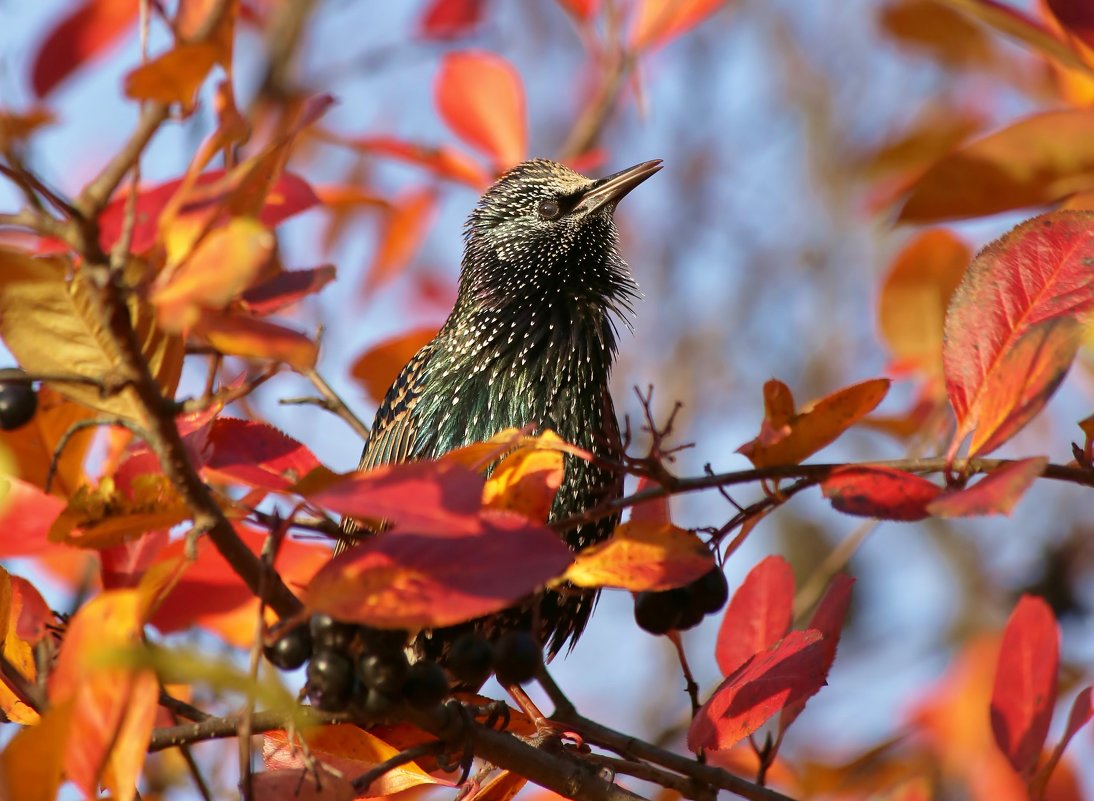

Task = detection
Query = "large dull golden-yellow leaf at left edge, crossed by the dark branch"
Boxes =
[0,248,183,421]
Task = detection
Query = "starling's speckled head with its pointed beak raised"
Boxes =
[461,159,661,311]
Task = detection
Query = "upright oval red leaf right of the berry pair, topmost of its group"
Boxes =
[714,555,794,676]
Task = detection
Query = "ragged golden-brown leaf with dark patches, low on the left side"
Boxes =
[49,473,190,548]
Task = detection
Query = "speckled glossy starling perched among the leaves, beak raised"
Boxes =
[336,160,661,659]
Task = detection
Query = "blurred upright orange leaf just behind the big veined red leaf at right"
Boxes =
[877,229,971,375]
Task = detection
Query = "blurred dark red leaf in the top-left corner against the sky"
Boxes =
[31,0,139,97]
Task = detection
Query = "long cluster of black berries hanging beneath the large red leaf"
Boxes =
[265,615,543,716]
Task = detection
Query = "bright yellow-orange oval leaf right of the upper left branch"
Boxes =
[151,217,275,333]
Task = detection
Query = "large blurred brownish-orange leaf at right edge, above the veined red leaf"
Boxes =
[899,108,1094,223]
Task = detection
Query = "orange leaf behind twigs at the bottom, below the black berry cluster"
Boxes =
[263,723,452,798]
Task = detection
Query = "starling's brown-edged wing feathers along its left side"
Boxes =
[335,343,433,556]
